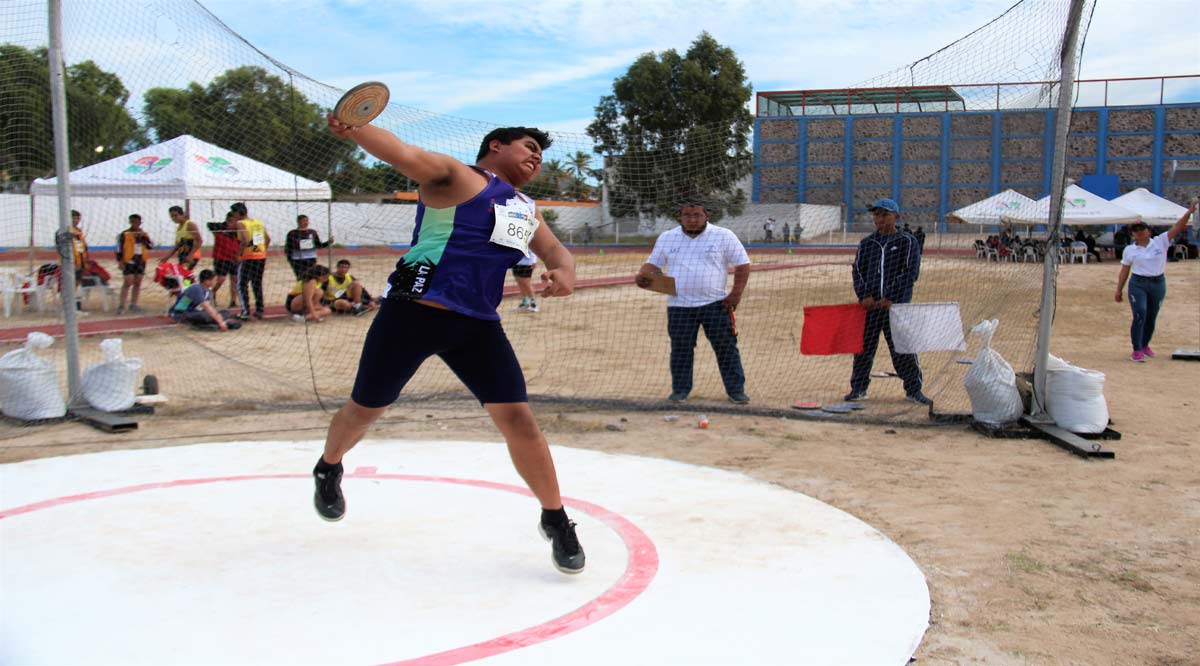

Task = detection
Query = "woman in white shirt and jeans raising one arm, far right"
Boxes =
[1114,200,1196,362]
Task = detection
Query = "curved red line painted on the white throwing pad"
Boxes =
[0,472,659,666]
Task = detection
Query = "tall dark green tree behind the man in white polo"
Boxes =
[587,32,754,217]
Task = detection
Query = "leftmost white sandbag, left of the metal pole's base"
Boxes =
[0,331,67,421]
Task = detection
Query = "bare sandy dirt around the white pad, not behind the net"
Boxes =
[0,253,1200,666]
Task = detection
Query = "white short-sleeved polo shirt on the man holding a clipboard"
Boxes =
[647,223,750,307]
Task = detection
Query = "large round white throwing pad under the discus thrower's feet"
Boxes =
[0,442,929,666]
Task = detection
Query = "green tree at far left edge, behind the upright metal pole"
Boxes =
[0,44,145,190]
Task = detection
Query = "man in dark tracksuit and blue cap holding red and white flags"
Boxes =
[846,199,934,404]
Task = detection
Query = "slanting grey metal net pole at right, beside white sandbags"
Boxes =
[1030,0,1085,420]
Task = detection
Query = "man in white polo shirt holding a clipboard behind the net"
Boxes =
[636,203,750,404]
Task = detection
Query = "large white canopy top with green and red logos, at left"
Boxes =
[30,134,331,202]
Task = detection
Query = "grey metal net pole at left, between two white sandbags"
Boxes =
[49,0,82,407]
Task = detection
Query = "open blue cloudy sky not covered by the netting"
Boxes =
[189,0,1200,132]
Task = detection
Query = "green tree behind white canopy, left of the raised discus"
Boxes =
[145,66,350,191]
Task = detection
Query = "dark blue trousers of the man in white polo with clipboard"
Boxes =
[667,301,746,395]
